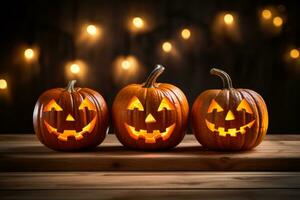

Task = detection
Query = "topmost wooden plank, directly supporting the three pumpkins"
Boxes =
[0,135,300,171]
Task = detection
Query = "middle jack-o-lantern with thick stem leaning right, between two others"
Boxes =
[112,65,189,150]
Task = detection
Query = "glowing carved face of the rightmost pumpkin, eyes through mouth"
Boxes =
[205,99,256,137]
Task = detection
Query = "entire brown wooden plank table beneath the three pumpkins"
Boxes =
[0,135,300,200]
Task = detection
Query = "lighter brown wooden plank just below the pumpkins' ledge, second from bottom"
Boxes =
[0,172,300,190]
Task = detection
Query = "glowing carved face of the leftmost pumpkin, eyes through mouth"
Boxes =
[43,97,97,141]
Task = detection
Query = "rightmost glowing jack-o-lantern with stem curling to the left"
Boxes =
[191,69,268,150]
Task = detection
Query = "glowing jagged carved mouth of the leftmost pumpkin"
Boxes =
[44,116,97,142]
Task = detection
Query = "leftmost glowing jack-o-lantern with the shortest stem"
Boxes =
[33,80,109,151]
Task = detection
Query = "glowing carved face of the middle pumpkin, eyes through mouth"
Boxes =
[124,96,176,143]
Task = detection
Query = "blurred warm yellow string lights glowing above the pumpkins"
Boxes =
[0,6,300,94]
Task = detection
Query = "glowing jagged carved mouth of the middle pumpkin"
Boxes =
[125,123,175,143]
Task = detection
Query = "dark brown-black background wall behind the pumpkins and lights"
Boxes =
[0,0,300,134]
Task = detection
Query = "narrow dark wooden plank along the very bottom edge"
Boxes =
[0,189,300,200]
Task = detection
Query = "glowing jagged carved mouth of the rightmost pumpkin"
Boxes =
[205,119,255,137]
